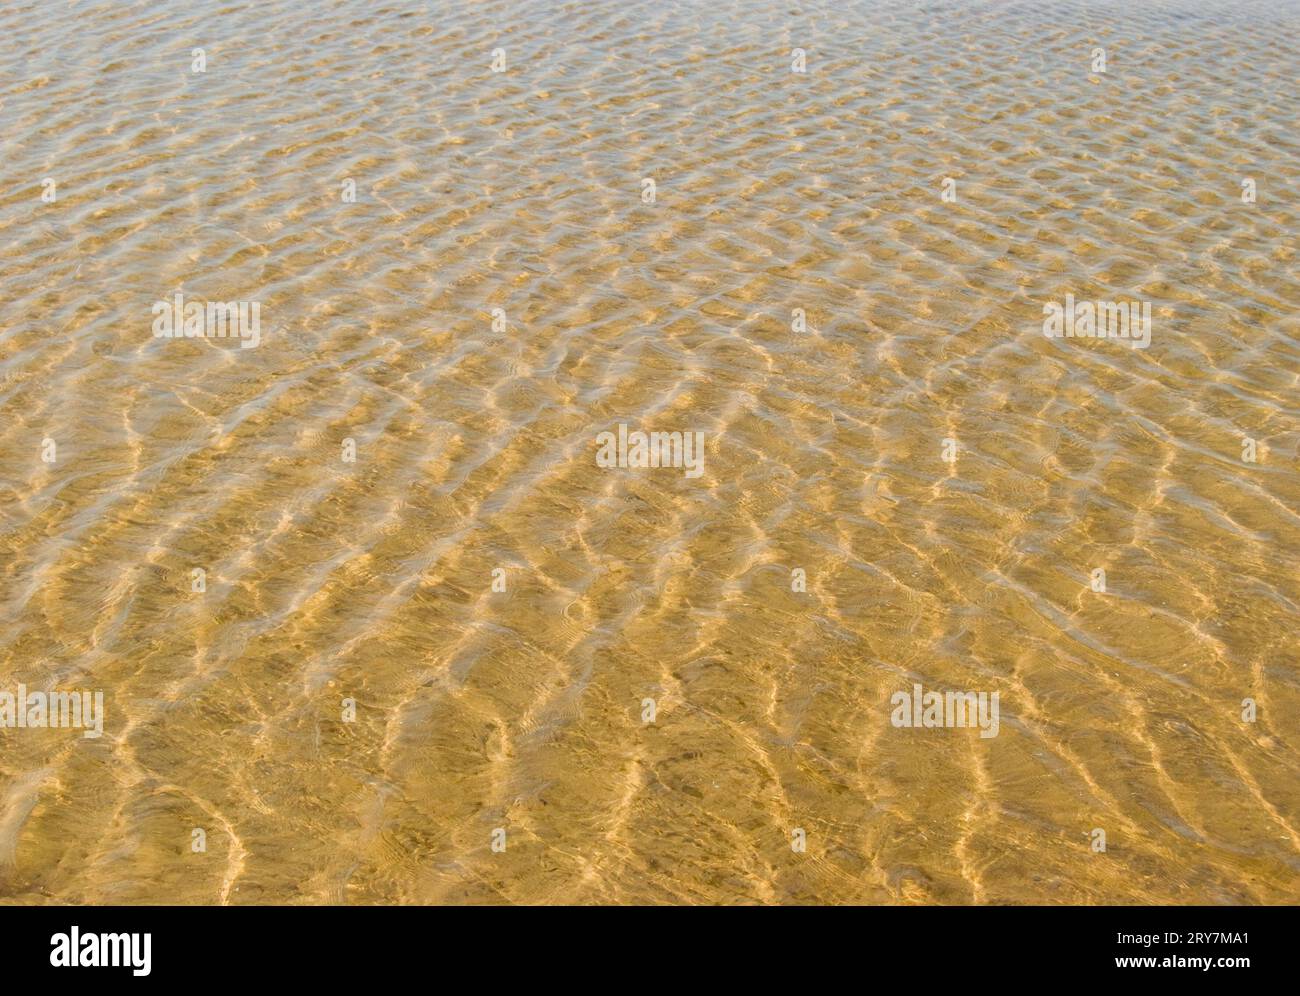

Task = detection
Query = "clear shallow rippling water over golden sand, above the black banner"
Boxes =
[0,0,1300,904]
